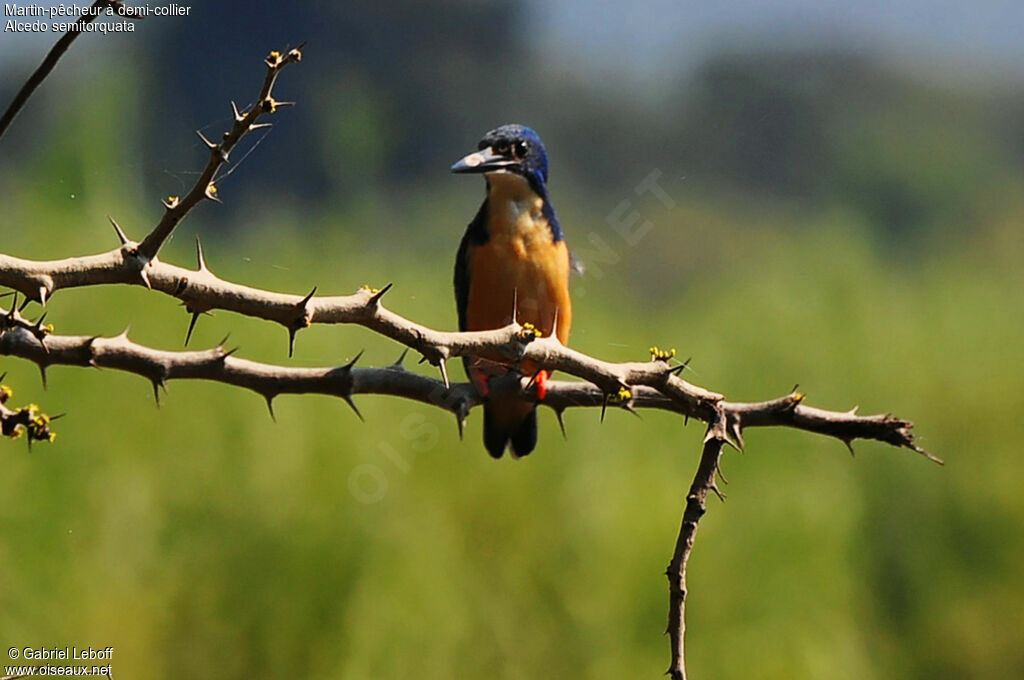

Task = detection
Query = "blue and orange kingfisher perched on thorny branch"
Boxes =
[452,124,572,458]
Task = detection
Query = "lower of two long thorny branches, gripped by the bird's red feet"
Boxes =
[0,301,938,461]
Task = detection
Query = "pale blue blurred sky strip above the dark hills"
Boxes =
[534,0,1024,85]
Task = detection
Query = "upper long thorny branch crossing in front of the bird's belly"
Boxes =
[0,205,933,458]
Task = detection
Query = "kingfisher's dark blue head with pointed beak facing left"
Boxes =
[452,124,548,186]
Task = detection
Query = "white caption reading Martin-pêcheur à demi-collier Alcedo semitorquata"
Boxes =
[3,2,191,33]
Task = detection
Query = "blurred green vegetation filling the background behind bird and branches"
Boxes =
[0,19,1024,680]
